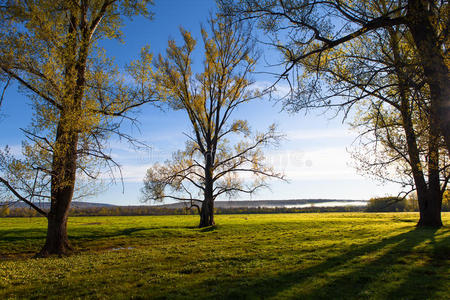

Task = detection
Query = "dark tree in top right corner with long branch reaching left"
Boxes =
[218,0,450,159]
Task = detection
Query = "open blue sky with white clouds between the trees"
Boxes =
[0,0,399,205]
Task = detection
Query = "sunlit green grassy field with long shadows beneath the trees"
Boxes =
[0,213,450,299]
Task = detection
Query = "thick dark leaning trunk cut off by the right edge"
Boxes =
[407,0,450,158]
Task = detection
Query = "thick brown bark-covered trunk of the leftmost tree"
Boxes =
[38,16,90,257]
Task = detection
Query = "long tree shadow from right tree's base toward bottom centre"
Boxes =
[181,229,444,299]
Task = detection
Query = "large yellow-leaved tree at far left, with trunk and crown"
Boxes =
[0,0,155,256]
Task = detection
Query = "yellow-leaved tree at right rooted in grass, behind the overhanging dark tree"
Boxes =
[328,27,450,227]
